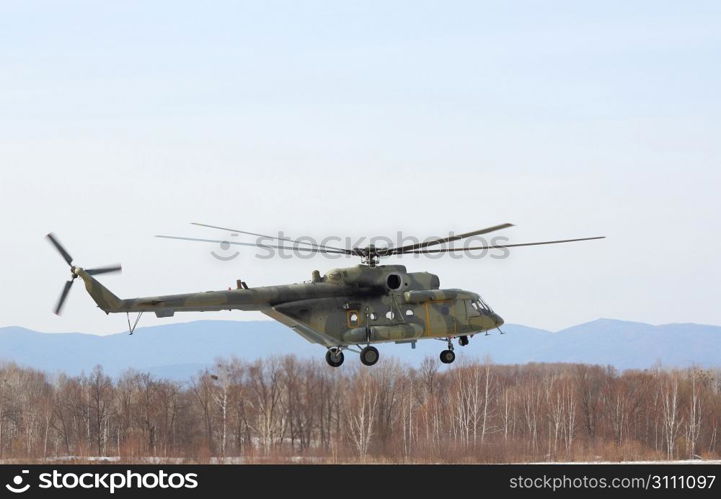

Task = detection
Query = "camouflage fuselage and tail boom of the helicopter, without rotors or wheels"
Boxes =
[72,265,503,349]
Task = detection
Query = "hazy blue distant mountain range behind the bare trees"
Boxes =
[0,319,721,380]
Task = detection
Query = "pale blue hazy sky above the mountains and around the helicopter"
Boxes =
[0,1,721,332]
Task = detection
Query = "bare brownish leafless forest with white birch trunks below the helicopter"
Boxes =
[0,357,721,463]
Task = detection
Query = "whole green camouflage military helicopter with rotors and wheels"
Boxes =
[46,223,605,367]
